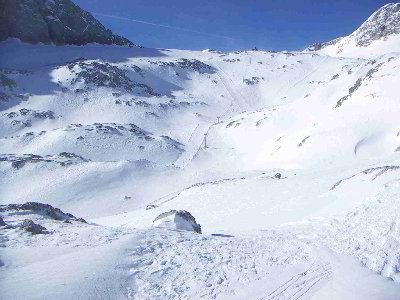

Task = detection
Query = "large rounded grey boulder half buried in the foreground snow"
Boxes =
[153,210,201,233]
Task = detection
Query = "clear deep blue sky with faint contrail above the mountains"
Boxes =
[73,0,393,50]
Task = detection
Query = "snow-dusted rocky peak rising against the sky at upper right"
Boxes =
[309,3,400,58]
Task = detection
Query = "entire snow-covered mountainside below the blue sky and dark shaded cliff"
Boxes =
[0,4,400,300]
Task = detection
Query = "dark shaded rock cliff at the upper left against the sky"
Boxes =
[0,0,135,46]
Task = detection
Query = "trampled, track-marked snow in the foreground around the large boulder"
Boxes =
[0,173,400,300]
